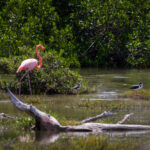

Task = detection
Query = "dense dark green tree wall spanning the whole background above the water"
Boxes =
[0,0,150,67]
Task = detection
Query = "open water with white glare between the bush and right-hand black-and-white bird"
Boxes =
[81,69,150,100]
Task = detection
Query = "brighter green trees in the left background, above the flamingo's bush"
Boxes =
[0,0,79,66]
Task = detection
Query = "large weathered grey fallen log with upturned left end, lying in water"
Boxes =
[8,89,150,132]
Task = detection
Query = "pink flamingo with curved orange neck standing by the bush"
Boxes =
[17,44,45,96]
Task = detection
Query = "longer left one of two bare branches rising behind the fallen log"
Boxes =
[81,111,116,123]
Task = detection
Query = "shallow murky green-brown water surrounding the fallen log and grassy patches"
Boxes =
[0,69,150,150]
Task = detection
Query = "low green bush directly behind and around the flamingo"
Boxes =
[0,47,82,94]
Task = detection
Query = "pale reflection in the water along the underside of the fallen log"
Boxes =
[17,131,150,144]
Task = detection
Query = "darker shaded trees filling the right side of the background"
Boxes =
[53,0,150,67]
